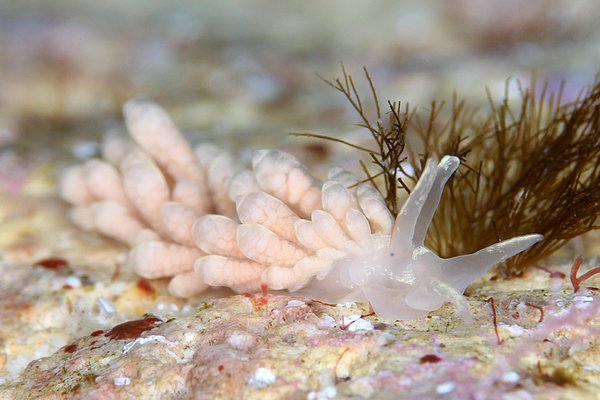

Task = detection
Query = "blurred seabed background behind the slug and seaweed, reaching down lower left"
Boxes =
[0,0,600,383]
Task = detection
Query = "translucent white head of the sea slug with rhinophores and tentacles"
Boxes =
[307,156,543,321]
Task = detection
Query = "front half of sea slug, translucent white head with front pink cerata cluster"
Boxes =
[193,150,542,320]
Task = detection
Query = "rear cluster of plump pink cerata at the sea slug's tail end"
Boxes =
[59,100,241,297]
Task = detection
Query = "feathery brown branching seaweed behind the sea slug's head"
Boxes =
[299,66,600,278]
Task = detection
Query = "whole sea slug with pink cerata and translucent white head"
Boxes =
[59,100,542,320]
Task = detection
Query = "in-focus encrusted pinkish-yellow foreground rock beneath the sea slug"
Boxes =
[0,271,600,399]
